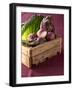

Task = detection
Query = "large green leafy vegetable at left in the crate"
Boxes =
[21,16,43,40]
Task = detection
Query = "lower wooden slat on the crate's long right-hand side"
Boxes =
[33,46,60,64]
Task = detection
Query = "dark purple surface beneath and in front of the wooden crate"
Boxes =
[21,52,64,77]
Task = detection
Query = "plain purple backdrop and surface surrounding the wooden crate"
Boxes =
[21,12,64,77]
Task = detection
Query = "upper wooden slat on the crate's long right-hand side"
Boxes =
[32,38,61,56]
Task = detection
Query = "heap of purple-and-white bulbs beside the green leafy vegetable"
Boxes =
[28,16,56,43]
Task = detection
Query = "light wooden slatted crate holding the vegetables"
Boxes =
[22,37,62,68]
